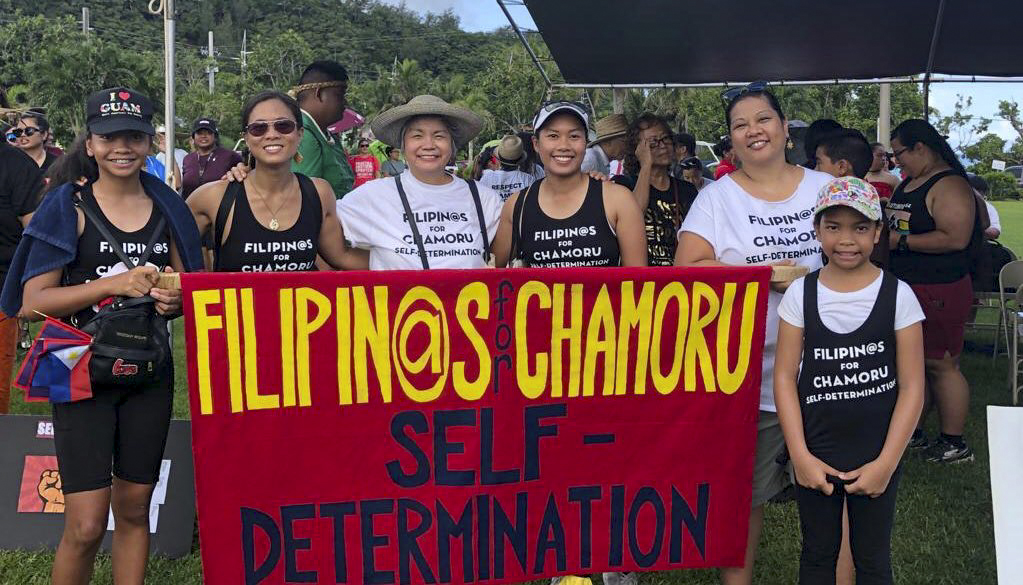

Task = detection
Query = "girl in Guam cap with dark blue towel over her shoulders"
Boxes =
[4,88,202,584]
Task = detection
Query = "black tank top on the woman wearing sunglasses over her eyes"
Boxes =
[214,173,323,272]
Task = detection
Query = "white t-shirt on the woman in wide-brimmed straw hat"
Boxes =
[337,171,501,270]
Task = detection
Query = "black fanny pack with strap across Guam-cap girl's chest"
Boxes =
[75,189,171,388]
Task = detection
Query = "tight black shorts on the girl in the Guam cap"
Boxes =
[53,370,174,494]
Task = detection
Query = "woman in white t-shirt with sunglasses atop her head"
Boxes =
[675,82,832,585]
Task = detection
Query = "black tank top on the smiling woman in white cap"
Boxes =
[520,179,622,268]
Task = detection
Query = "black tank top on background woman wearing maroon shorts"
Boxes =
[887,171,970,284]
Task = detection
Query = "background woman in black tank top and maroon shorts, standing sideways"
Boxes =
[888,120,982,463]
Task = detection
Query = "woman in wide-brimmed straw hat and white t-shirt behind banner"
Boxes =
[337,95,501,270]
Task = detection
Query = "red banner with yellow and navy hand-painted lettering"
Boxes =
[181,268,770,585]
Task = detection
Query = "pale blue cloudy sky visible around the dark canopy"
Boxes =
[384,0,1023,146]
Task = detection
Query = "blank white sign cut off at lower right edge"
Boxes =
[987,406,1023,585]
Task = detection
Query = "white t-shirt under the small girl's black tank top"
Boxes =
[777,273,924,334]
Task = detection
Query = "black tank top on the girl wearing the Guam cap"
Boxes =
[63,185,171,326]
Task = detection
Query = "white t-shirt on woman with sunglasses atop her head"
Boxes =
[679,169,833,412]
